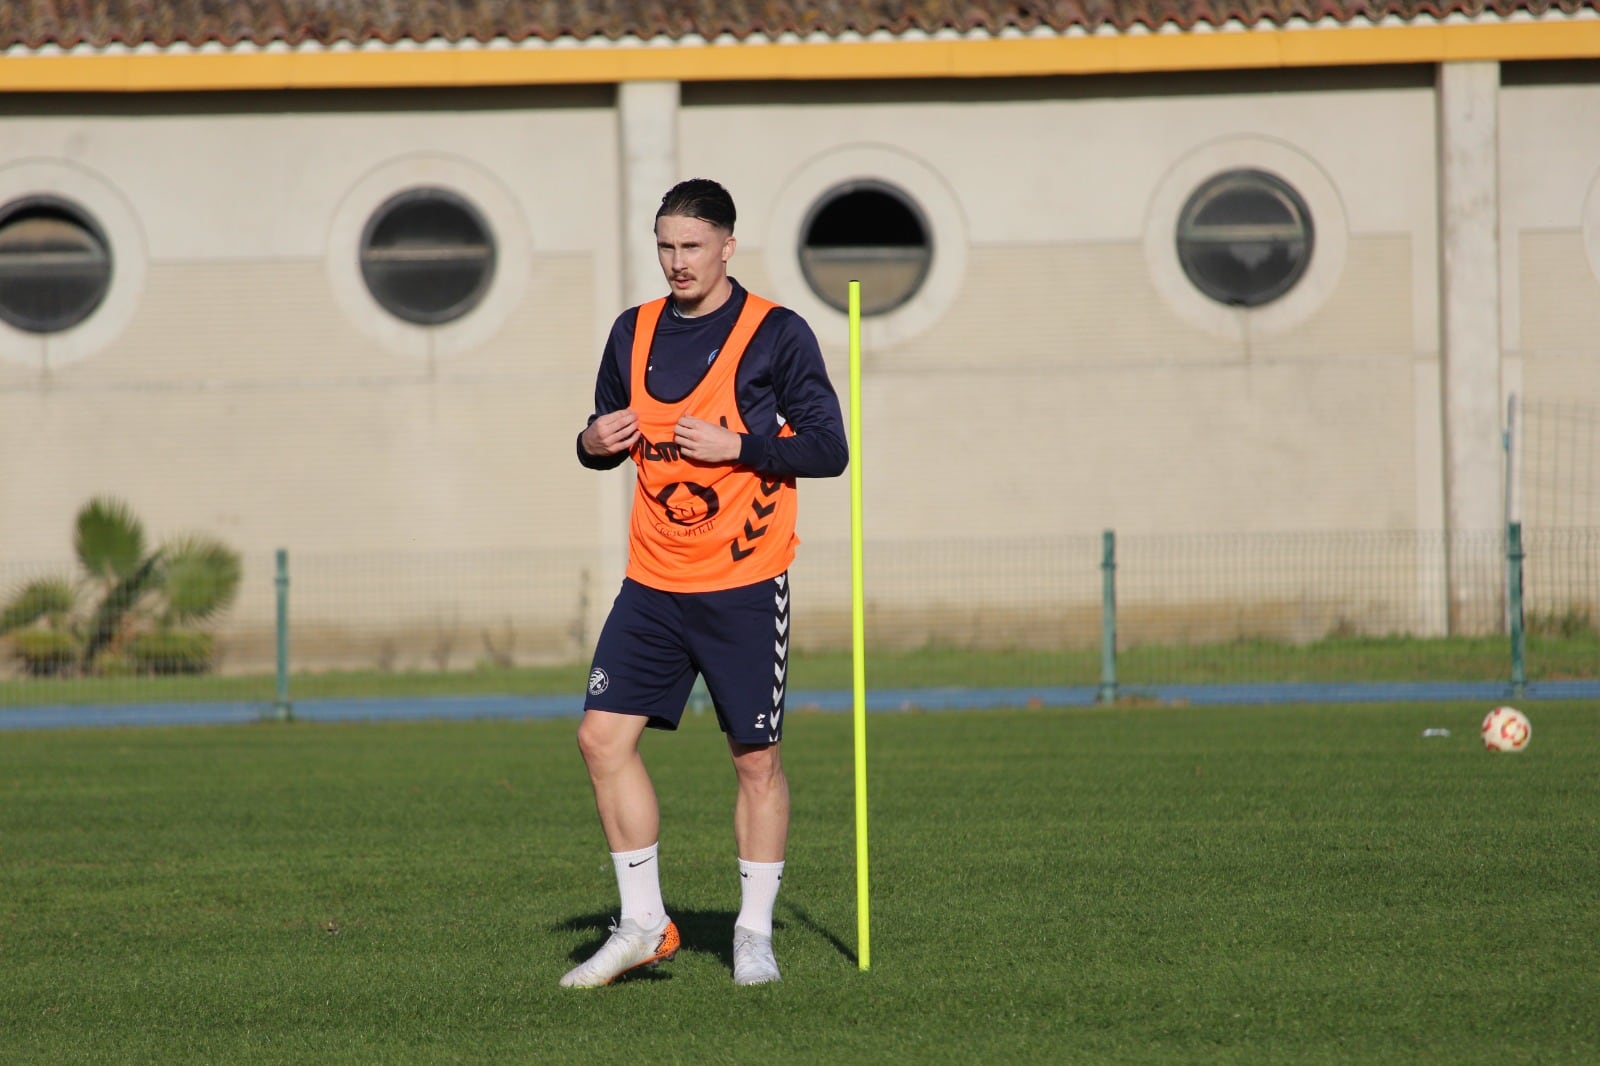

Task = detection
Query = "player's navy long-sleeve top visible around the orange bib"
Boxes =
[578,279,850,477]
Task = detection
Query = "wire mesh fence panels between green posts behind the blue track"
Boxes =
[0,528,1600,706]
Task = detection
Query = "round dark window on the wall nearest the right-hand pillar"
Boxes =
[1178,170,1312,307]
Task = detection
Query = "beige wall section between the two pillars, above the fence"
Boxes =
[680,80,1442,557]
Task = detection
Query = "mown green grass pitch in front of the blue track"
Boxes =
[0,703,1600,1066]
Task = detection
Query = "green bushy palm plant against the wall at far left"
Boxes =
[0,496,242,674]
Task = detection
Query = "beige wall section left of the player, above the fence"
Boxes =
[0,92,619,559]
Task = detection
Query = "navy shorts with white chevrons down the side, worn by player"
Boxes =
[584,573,789,744]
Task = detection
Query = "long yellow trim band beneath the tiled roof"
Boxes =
[0,18,1600,93]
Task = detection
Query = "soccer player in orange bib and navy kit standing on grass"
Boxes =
[562,178,850,988]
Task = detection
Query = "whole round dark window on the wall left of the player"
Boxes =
[360,189,494,325]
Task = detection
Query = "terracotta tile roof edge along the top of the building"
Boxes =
[0,0,1600,48]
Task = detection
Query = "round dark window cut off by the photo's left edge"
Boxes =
[0,197,110,333]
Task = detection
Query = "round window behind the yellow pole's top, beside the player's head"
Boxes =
[800,181,933,315]
